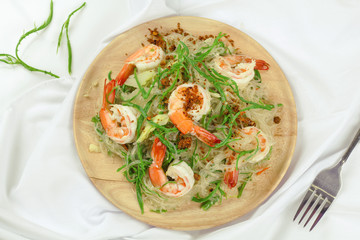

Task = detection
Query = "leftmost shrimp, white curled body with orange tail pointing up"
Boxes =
[99,80,137,144]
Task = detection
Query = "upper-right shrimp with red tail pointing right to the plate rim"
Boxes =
[214,55,269,88]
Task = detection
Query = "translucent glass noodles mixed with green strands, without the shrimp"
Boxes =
[92,31,281,213]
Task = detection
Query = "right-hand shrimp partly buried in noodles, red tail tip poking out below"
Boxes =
[224,127,270,189]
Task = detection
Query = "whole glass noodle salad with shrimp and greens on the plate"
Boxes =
[92,27,281,212]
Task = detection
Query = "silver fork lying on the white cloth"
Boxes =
[293,129,360,231]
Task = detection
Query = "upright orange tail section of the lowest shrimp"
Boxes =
[149,138,167,187]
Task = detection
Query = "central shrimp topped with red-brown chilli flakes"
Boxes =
[168,84,221,147]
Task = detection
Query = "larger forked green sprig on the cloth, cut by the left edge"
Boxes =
[0,0,59,78]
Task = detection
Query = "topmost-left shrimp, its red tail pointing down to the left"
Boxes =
[115,44,165,85]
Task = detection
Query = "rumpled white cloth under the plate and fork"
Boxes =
[0,0,360,240]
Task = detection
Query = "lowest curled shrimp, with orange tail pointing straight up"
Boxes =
[149,138,195,197]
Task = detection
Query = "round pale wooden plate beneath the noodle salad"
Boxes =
[73,17,297,230]
